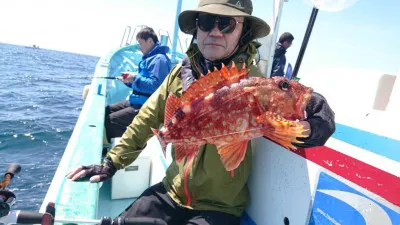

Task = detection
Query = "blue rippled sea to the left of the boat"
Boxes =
[0,43,99,211]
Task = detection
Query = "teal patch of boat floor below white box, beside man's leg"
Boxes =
[97,180,136,219]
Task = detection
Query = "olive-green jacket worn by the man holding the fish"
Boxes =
[107,44,262,216]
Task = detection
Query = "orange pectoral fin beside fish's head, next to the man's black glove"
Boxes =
[257,112,307,149]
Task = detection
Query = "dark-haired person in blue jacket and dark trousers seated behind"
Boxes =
[104,27,172,142]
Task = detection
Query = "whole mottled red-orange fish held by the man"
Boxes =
[153,62,312,171]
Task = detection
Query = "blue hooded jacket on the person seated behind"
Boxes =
[129,42,172,105]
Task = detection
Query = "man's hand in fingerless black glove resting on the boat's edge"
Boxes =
[66,158,117,182]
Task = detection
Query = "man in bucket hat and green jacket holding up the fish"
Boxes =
[67,0,335,225]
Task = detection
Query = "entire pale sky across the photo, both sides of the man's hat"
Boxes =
[0,0,400,73]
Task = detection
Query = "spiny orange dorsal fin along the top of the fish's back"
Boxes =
[181,62,247,105]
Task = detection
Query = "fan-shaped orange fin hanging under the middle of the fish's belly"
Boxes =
[218,141,248,171]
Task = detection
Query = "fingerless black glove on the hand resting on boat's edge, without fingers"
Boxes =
[76,158,117,182]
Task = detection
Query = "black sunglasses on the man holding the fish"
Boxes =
[196,14,243,34]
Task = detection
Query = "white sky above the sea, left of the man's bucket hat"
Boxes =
[0,0,196,56]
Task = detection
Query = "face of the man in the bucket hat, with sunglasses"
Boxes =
[197,14,244,61]
